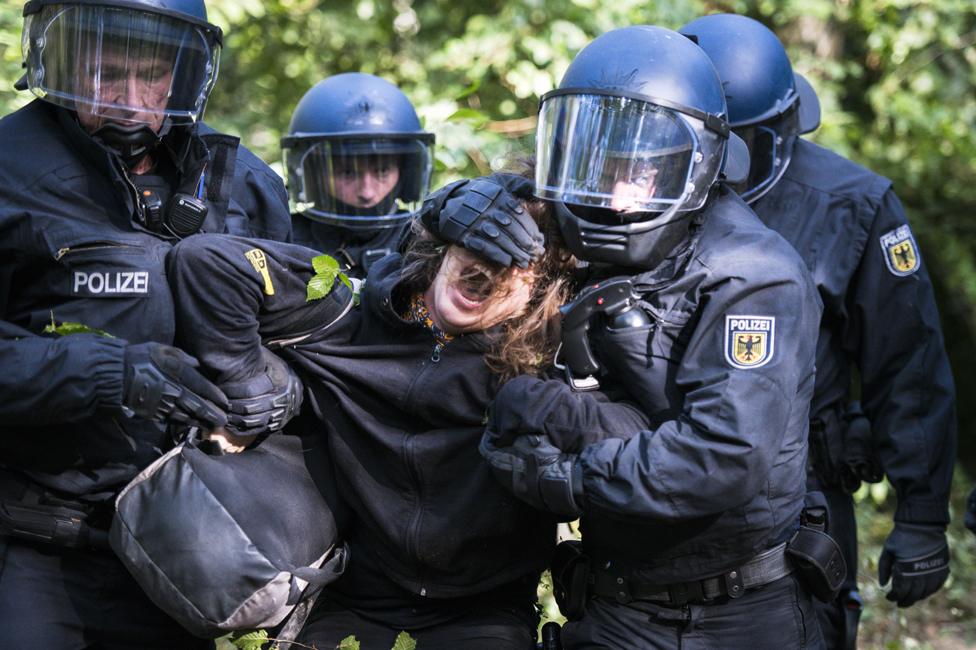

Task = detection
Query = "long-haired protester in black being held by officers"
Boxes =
[169,182,643,650]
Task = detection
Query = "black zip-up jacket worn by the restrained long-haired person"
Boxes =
[169,235,576,598]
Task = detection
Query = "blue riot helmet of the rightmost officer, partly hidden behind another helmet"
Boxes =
[680,14,820,203]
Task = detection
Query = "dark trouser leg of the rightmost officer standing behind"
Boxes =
[815,488,857,650]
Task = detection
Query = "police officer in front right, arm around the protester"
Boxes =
[430,26,822,649]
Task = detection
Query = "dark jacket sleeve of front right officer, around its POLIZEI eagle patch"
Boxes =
[580,251,821,520]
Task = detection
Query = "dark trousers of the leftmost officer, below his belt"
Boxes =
[0,537,214,650]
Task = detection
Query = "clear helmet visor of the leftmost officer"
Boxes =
[23,5,220,125]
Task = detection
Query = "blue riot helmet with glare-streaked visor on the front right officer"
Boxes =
[536,26,748,268]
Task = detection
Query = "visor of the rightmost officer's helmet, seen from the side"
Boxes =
[732,107,799,203]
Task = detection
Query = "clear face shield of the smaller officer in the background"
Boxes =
[284,135,433,230]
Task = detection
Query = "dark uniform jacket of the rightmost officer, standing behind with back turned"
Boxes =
[753,139,956,524]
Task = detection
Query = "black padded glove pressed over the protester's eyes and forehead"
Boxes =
[420,174,545,268]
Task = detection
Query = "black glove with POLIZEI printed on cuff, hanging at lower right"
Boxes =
[878,522,949,607]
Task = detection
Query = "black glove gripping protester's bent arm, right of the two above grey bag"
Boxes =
[220,348,302,436]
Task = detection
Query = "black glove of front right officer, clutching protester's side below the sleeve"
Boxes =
[479,431,583,521]
